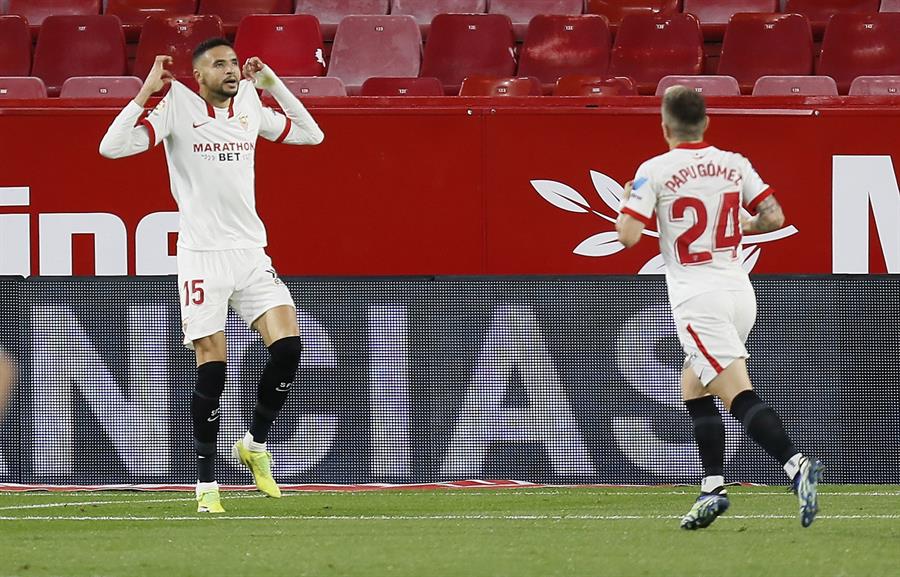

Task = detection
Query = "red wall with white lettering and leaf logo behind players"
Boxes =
[0,98,900,276]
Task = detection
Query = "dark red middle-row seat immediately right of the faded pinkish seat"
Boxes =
[420,14,516,95]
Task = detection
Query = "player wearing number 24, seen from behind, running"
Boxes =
[616,86,822,529]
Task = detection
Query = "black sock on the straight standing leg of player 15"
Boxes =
[191,361,225,483]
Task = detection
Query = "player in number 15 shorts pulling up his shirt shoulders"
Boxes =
[100,38,324,513]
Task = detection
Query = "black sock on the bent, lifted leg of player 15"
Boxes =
[250,337,303,443]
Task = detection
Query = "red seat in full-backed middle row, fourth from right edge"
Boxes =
[518,14,612,93]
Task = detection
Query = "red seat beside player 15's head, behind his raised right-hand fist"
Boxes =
[234,14,325,76]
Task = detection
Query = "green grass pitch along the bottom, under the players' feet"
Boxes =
[0,485,900,577]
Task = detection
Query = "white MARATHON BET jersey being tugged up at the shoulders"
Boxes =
[141,80,291,250]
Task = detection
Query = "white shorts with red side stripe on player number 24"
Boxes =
[672,289,756,386]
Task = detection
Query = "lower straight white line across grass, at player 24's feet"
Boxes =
[0,515,900,521]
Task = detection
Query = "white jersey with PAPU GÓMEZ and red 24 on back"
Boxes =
[622,143,774,307]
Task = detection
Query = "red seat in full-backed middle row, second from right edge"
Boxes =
[718,14,813,94]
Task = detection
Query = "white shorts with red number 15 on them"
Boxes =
[178,247,295,349]
